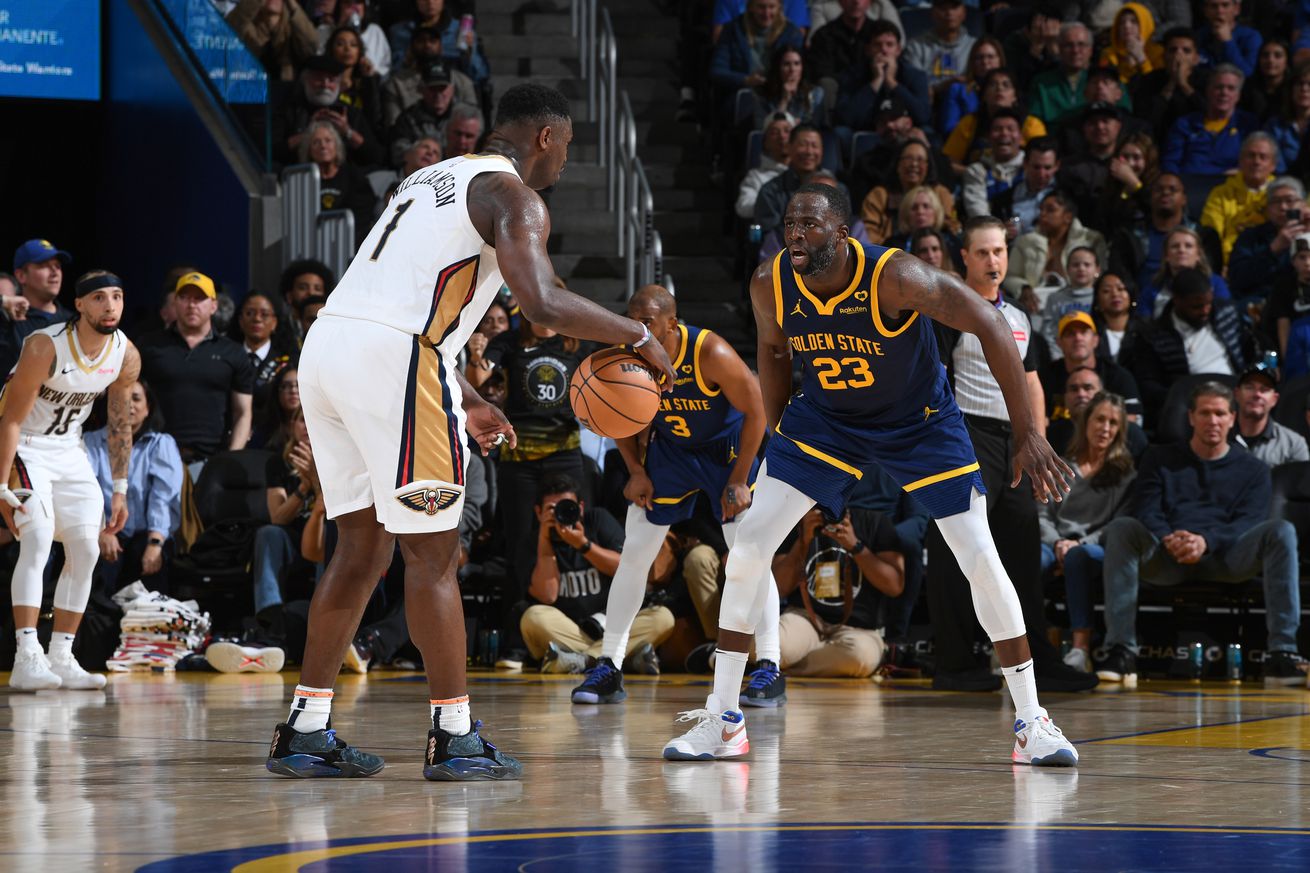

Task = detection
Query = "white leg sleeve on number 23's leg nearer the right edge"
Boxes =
[937,492,1024,642]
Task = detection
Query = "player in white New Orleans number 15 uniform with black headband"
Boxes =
[0,270,141,691]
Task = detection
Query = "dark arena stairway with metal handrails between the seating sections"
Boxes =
[477,0,755,359]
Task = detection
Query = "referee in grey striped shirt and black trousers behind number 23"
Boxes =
[927,216,1096,691]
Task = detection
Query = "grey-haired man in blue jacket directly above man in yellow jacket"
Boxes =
[1159,63,1260,176]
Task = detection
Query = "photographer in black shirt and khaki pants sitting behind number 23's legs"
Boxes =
[773,507,905,679]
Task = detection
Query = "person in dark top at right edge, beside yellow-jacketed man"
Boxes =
[1227,176,1310,300]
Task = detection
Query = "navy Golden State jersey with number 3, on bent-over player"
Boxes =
[651,324,743,446]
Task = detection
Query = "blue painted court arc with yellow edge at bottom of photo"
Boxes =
[140,822,1310,873]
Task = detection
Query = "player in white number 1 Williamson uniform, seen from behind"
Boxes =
[266,84,673,781]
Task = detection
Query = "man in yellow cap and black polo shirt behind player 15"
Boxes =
[139,273,254,477]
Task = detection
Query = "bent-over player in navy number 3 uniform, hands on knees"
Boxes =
[572,284,786,705]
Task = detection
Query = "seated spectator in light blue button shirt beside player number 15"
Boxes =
[83,381,182,594]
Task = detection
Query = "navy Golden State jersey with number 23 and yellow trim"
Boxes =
[773,234,945,421]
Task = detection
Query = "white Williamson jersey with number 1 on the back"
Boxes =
[321,155,517,360]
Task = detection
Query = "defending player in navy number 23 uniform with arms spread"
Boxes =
[664,185,1078,766]
